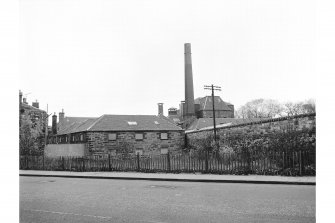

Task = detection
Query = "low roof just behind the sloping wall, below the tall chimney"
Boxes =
[187,118,264,130]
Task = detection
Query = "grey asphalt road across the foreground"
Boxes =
[20,176,315,223]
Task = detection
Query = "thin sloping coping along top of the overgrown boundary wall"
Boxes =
[185,113,316,134]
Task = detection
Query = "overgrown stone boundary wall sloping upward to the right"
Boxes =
[186,113,316,150]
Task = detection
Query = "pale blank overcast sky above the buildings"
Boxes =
[19,0,316,117]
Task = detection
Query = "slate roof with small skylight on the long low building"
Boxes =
[58,115,182,135]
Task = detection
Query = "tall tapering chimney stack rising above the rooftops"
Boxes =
[184,43,195,117]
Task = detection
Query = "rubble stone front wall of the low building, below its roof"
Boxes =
[86,131,184,155]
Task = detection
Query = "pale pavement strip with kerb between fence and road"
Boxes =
[19,170,316,185]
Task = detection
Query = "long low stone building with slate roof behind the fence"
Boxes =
[45,115,184,157]
